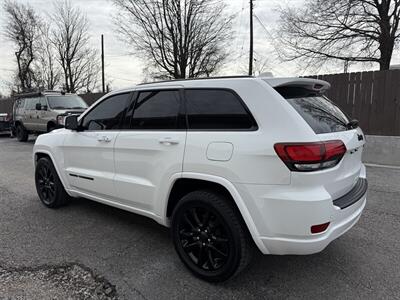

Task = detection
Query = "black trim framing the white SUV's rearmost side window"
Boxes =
[183,87,259,132]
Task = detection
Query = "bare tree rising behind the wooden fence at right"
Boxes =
[279,0,400,70]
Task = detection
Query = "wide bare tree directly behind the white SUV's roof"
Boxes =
[113,0,231,78]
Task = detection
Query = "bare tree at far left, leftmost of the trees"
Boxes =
[3,0,39,91]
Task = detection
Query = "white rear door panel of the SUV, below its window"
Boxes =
[114,131,186,214]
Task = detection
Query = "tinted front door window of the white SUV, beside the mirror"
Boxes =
[82,93,130,130]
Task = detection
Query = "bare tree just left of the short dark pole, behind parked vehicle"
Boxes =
[52,0,99,93]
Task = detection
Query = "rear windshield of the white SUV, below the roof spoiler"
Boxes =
[276,87,349,134]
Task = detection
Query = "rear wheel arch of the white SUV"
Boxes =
[164,173,269,253]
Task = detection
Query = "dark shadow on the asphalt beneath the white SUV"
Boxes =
[64,198,358,298]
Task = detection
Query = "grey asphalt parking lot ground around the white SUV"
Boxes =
[0,136,400,299]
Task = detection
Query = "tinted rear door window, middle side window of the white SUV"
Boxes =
[130,90,180,129]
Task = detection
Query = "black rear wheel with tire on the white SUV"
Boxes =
[171,191,253,282]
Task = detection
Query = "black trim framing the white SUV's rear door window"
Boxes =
[120,87,186,132]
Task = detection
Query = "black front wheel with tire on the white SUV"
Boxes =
[35,157,70,208]
